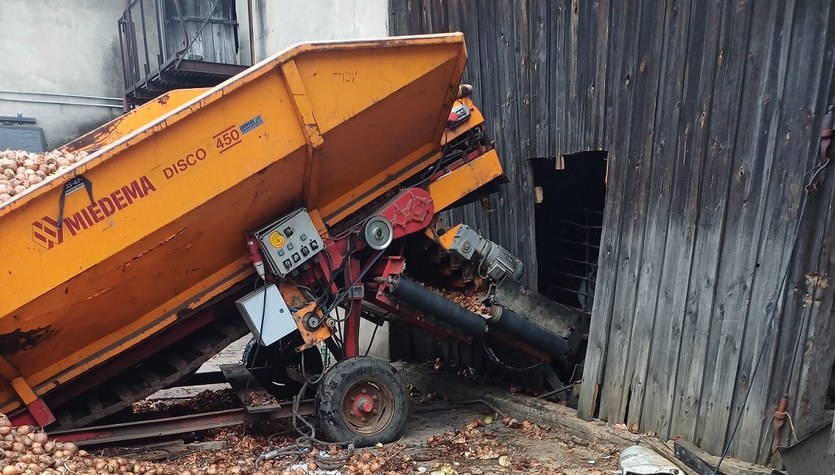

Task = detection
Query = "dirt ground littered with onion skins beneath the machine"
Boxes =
[124,339,618,475]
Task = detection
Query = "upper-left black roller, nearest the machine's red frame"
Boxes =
[390,276,487,335]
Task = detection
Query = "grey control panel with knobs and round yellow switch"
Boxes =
[255,208,325,277]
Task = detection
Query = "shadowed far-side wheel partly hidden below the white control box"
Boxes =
[241,330,324,401]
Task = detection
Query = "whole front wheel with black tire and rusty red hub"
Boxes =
[316,356,409,447]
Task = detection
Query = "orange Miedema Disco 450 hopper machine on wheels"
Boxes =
[0,34,580,443]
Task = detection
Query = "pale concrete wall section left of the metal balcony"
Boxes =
[0,0,124,148]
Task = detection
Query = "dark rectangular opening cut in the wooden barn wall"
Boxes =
[532,150,607,313]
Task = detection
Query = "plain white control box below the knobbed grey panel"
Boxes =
[235,284,298,346]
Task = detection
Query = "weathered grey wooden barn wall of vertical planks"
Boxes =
[390,0,835,462]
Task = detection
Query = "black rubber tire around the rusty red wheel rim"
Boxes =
[316,356,409,447]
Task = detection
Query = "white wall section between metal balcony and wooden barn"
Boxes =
[238,0,388,61]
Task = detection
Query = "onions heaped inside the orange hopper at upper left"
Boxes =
[0,150,87,204]
